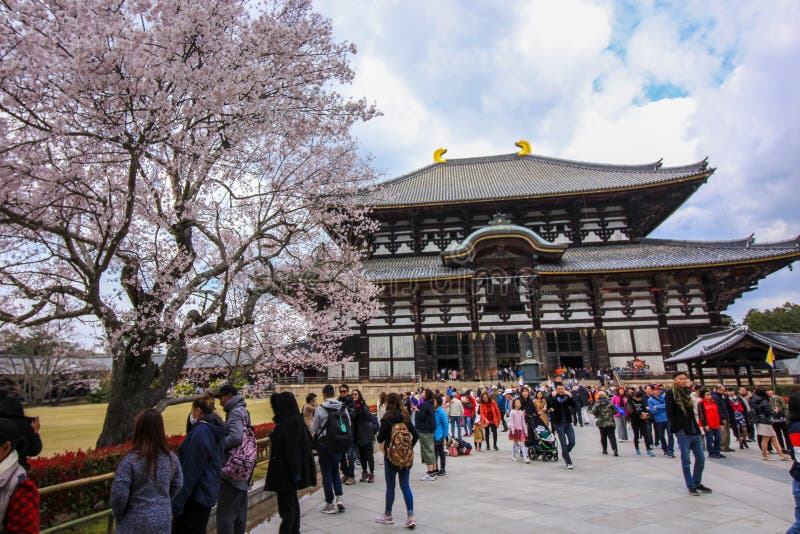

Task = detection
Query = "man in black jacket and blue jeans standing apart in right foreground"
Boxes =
[664,371,711,496]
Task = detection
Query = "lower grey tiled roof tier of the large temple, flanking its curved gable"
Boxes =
[364,238,800,281]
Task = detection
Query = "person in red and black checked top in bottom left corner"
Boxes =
[0,417,39,534]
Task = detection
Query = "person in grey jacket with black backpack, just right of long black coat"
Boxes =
[311,384,352,514]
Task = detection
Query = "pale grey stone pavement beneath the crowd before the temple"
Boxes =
[251,426,794,534]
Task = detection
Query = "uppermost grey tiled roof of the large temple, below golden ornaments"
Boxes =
[359,154,714,208]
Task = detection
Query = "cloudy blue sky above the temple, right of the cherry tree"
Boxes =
[315,0,800,319]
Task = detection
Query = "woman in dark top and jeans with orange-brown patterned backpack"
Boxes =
[375,393,419,529]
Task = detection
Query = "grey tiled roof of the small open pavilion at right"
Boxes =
[664,326,800,363]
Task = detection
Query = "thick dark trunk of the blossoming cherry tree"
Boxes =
[97,340,188,447]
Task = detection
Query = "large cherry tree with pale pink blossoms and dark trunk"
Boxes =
[0,0,377,446]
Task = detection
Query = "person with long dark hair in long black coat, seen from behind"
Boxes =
[264,391,317,534]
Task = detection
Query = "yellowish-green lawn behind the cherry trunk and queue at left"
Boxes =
[25,399,272,456]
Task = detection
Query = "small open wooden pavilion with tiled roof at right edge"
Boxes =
[664,326,800,386]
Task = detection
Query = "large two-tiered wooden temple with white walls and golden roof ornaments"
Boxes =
[334,141,800,378]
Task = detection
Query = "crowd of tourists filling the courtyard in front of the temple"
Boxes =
[0,373,800,534]
